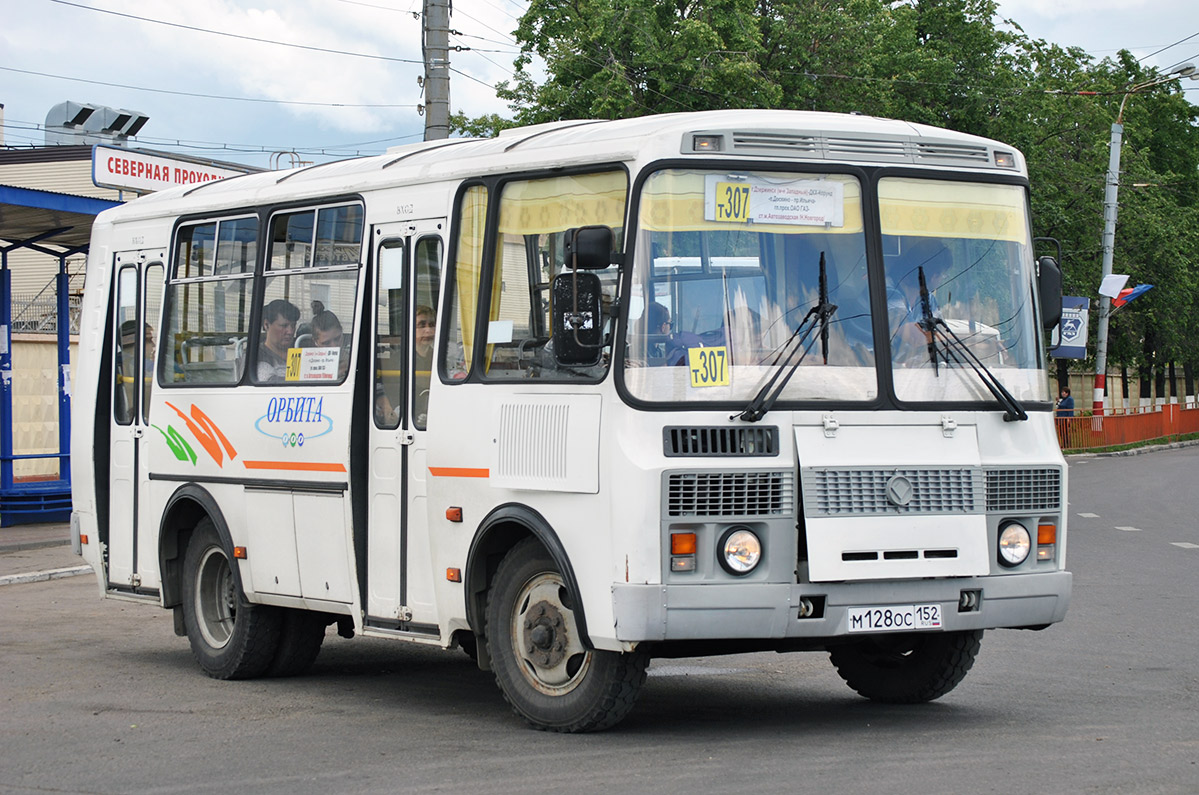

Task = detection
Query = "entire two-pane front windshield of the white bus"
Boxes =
[623,169,1046,403]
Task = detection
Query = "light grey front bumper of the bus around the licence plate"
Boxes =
[613,572,1073,643]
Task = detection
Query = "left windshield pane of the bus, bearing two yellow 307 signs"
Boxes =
[625,169,878,403]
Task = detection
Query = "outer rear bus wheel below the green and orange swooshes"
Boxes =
[183,518,282,679]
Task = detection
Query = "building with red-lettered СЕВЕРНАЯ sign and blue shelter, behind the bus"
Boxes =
[0,110,260,525]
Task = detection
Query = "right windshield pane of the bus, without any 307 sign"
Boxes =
[879,179,1048,402]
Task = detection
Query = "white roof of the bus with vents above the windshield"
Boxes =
[102,110,1025,222]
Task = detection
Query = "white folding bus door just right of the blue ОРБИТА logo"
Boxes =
[367,219,445,634]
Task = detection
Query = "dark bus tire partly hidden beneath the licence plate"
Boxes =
[829,630,982,704]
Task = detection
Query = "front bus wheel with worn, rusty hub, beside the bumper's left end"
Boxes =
[487,538,649,731]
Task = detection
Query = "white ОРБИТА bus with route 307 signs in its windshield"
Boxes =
[72,110,1071,731]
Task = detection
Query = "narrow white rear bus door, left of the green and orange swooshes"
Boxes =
[107,251,163,590]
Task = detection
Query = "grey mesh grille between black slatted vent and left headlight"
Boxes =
[667,470,795,517]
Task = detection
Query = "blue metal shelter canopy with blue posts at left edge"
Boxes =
[0,185,121,526]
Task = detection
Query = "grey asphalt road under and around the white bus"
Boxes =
[0,447,1199,795]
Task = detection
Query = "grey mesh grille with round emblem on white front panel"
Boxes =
[803,469,982,516]
